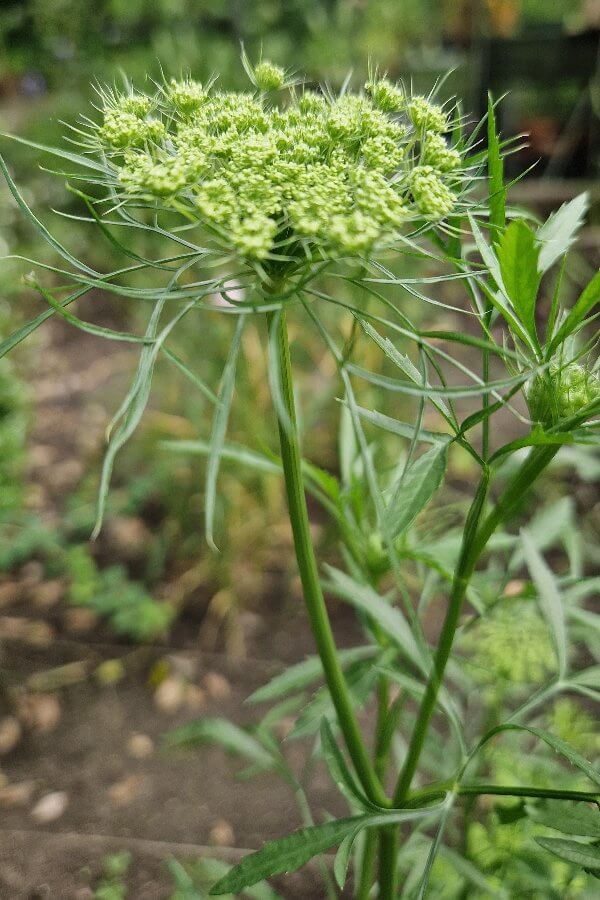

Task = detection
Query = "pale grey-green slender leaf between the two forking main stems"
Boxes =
[325,565,429,674]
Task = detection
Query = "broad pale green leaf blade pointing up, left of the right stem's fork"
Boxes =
[385,442,448,539]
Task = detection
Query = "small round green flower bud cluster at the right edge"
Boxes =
[527,363,600,426]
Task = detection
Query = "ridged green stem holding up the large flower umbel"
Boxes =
[267,310,389,806]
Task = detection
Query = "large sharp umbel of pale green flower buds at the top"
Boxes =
[93,67,462,260]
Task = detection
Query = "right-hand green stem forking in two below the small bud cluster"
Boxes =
[393,446,558,807]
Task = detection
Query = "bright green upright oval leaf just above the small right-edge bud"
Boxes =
[496,219,542,341]
